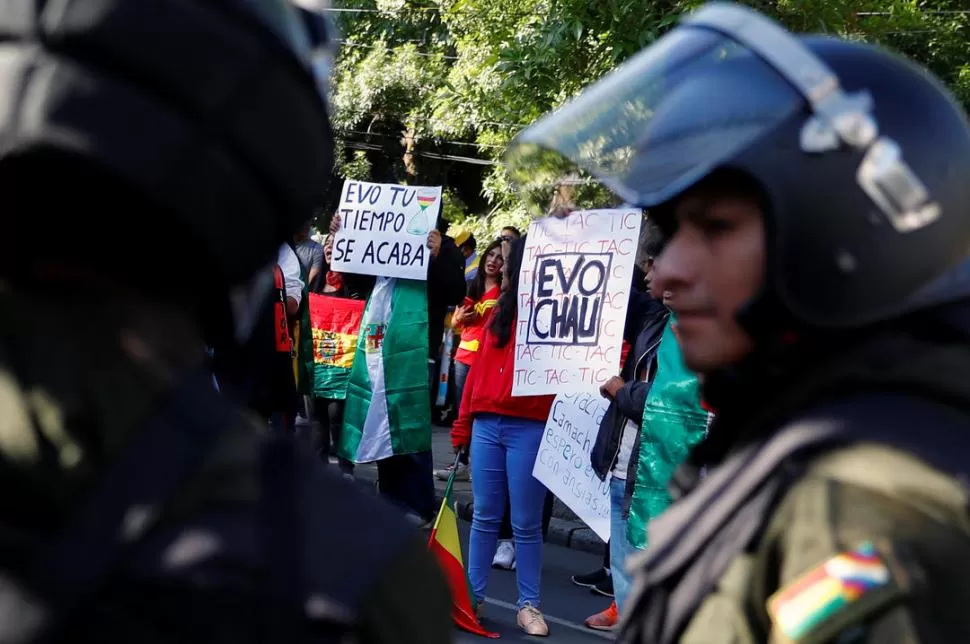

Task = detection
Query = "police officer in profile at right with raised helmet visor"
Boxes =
[510,4,970,644]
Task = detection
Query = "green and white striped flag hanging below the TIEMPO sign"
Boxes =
[338,277,431,463]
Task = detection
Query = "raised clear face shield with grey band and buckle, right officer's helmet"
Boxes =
[505,3,939,232]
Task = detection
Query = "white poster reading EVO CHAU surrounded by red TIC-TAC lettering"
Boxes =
[512,210,643,396]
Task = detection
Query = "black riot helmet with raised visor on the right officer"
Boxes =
[507,3,970,329]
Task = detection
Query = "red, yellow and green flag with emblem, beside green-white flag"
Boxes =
[310,293,365,400]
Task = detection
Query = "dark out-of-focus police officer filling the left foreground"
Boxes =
[0,0,451,644]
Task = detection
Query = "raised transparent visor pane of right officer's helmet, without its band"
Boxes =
[505,26,805,210]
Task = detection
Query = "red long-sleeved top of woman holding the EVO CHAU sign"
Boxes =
[451,324,555,447]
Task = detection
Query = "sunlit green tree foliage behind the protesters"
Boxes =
[334,0,970,236]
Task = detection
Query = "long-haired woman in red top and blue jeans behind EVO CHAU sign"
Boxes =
[451,238,553,636]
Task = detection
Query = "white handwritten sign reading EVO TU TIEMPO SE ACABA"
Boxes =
[332,179,441,280]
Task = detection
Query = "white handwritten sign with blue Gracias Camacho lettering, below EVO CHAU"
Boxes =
[532,393,610,541]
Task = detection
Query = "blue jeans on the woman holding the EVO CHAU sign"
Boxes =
[468,414,546,608]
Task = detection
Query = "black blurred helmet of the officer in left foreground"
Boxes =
[0,0,335,292]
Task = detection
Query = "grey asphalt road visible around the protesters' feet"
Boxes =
[455,521,613,644]
